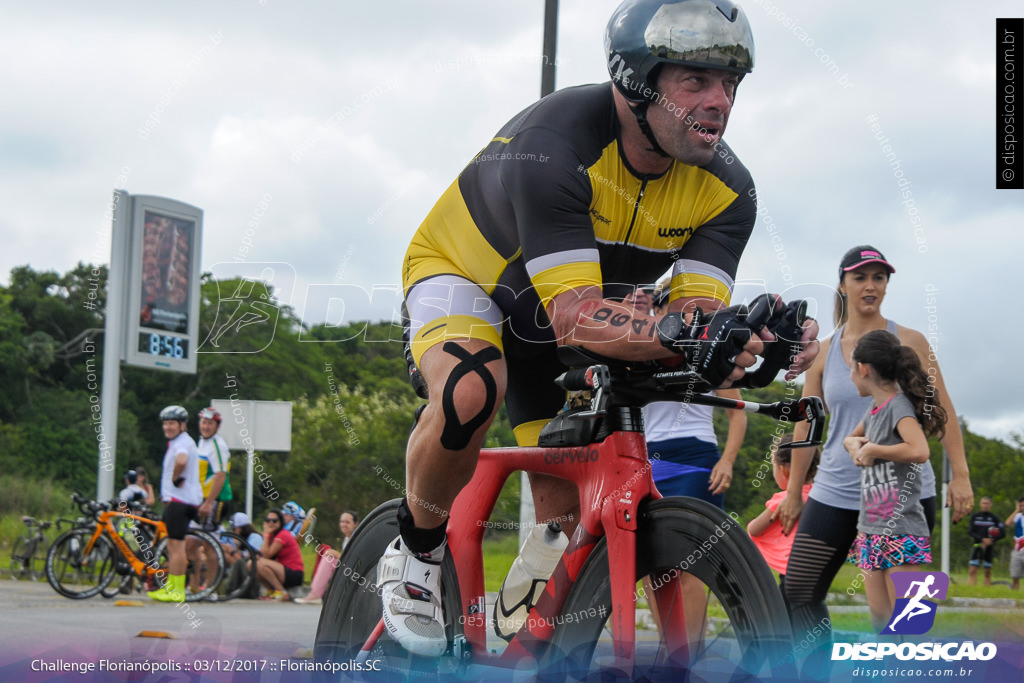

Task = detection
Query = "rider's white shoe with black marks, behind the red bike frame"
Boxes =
[495,522,569,640]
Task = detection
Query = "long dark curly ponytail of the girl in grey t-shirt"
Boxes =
[853,330,946,438]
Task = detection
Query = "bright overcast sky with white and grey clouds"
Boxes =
[0,0,1024,444]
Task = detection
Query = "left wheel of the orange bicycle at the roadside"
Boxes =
[46,528,117,600]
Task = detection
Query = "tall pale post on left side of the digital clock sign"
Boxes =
[96,189,131,501]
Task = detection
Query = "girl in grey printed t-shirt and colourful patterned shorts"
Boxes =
[843,330,946,632]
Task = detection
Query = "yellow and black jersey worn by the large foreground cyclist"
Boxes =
[403,83,756,340]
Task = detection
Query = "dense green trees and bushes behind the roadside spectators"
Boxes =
[0,263,1024,563]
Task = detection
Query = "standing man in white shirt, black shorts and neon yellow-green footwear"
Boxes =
[148,405,203,602]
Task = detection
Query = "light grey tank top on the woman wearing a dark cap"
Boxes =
[811,321,935,510]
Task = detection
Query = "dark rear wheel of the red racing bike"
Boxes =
[313,500,463,678]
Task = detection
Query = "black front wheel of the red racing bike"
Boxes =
[541,498,792,680]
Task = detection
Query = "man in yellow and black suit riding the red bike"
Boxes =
[377,0,817,655]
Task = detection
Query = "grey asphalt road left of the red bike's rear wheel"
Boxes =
[0,580,319,682]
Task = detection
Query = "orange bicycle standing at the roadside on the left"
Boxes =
[46,494,225,602]
